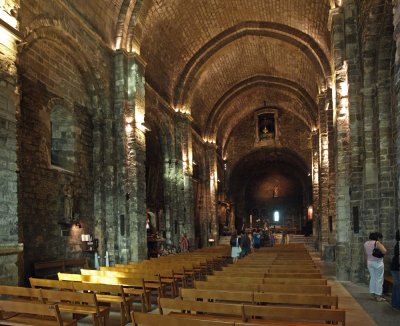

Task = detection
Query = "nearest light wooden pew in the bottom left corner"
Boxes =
[0,300,77,326]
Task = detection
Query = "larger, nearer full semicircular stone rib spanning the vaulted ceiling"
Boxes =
[173,22,332,107]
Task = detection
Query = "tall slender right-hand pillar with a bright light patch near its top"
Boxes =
[332,8,351,280]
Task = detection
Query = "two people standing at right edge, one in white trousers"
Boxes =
[364,230,400,309]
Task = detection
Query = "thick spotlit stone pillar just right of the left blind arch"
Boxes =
[112,50,147,262]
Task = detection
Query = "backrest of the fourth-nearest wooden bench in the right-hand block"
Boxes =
[195,281,331,295]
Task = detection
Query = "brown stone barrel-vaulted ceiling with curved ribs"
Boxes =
[74,0,332,152]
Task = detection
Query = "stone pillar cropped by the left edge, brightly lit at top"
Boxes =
[0,0,23,285]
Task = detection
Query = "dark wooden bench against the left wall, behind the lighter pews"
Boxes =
[33,258,89,279]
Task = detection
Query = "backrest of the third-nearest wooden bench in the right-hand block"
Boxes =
[179,289,338,309]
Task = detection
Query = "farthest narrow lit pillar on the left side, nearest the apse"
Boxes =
[206,143,218,243]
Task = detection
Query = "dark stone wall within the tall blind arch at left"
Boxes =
[17,1,111,276]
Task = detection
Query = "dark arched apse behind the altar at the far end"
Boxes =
[227,148,312,228]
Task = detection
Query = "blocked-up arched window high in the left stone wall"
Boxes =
[50,104,80,171]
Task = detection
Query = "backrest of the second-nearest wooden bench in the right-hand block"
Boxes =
[160,298,345,326]
